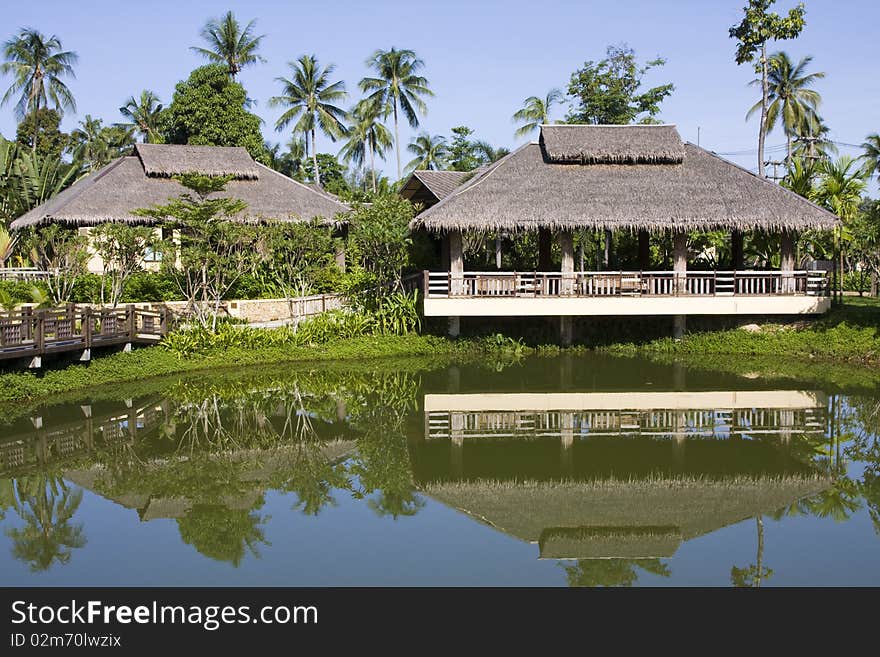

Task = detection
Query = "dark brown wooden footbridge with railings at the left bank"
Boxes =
[0,305,171,360]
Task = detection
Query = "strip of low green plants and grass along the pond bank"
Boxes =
[0,298,880,403]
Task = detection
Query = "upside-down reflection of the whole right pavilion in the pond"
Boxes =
[411,390,828,559]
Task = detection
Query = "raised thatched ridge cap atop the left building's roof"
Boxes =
[135,144,260,180]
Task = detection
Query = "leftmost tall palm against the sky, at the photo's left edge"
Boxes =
[0,28,78,151]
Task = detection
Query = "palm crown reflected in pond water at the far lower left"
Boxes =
[6,475,86,572]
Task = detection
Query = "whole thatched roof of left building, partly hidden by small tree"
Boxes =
[11,144,349,230]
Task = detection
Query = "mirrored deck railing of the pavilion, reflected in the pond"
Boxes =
[426,407,825,439]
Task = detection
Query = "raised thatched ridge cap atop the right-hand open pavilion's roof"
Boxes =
[540,125,684,164]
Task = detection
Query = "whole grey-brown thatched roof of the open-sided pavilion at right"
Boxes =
[412,126,838,231]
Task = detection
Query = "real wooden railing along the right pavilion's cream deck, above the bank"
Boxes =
[422,271,829,297]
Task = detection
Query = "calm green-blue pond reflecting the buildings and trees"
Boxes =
[0,355,880,586]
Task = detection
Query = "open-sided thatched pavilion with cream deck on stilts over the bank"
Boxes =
[410,125,840,344]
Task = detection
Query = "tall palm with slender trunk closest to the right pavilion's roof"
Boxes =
[360,47,434,179]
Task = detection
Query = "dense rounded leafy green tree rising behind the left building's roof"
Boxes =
[159,64,266,161]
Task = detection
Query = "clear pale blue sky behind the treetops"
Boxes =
[0,0,880,179]
